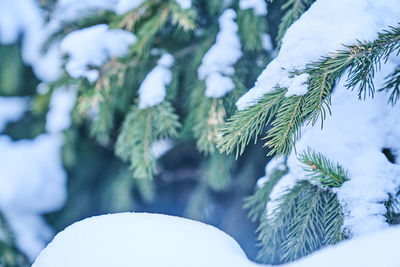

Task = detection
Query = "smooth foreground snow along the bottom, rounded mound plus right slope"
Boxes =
[32,213,400,267]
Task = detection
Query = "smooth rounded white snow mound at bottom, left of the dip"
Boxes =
[32,213,257,267]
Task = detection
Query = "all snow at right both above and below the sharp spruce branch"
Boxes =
[256,0,400,236]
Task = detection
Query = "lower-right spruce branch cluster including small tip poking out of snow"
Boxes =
[245,150,347,264]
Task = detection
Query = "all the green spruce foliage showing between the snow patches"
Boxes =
[0,0,400,266]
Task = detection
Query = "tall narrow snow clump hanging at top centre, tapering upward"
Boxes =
[198,9,242,98]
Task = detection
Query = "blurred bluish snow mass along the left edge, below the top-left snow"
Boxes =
[0,89,76,260]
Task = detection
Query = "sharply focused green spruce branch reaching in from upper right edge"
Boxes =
[218,24,400,158]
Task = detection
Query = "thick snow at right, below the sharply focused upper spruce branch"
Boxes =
[267,55,400,235]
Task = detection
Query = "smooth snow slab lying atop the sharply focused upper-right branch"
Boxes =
[236,0,400,109]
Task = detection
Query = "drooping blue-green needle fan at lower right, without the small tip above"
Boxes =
[258,181,343,264]
